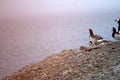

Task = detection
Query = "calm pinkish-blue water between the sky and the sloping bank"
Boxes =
[0,12,120,78]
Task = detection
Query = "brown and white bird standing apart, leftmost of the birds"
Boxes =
[89,29,103,45]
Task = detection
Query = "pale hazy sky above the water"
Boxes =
[0,0,120,16]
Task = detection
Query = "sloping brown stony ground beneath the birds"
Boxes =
[3,41,120,80]
